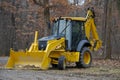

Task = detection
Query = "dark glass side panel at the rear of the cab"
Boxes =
[71,21,85,51]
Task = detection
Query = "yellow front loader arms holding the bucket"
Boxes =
[28,31,65,69]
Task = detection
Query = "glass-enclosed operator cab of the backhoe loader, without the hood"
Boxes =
[52,18,86,51]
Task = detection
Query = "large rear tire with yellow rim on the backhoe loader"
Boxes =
[76,47,92,68]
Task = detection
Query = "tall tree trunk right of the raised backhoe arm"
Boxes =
[105,0,112,59]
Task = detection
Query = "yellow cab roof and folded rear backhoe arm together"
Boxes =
[55,10,102,51]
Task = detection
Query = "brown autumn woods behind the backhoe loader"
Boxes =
[0,0,120,59]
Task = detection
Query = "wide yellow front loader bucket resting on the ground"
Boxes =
[6,50,50,69]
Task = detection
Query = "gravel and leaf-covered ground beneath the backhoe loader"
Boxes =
[0,57,120,80]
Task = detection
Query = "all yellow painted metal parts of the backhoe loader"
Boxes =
[6,10,102,69]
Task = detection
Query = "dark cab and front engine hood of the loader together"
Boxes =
[38,18,86,51]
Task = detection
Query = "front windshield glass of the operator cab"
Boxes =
[52,20,70,35]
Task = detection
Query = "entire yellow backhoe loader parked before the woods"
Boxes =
[6,9,102,70]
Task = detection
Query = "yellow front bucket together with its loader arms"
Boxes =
[6,32,72,69]
